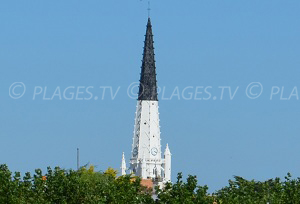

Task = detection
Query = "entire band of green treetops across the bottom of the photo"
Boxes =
[0,165,300,204]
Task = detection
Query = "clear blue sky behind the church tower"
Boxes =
[0,0,300,191]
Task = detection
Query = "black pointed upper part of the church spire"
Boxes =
[138,18,158,101]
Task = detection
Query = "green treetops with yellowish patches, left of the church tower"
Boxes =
[0,165,153,204]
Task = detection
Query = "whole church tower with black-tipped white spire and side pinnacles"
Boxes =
[122,18,171,185]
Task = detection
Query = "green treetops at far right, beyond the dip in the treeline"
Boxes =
[216,173,300,204]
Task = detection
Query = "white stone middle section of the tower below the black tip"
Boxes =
[130,101,163,178]
